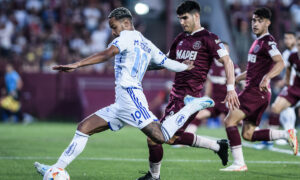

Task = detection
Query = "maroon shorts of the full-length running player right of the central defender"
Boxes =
[239,87,271,126]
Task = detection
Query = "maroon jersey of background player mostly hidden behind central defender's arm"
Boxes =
[208,59,241,101]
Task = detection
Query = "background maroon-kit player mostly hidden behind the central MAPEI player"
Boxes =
[185,42,241,133]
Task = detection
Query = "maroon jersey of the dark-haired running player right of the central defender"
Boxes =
[246,34,280,88]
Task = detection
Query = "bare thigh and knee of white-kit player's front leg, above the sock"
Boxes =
[77,114,109,135]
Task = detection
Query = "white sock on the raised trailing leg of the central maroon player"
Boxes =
[192,134,220,152]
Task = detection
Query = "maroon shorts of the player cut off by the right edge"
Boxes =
[279,86,300,106]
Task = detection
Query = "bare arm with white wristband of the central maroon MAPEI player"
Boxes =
[219,55,240,110]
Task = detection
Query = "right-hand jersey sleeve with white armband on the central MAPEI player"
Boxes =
[207,34,228,59]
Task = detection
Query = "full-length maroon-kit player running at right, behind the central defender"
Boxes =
[221,8,297,171]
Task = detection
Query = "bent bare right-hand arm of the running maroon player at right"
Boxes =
[259,54,284,91]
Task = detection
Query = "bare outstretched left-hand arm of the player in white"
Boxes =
[53,45,119,72]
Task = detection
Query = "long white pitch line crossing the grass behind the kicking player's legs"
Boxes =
[0,156,300,165]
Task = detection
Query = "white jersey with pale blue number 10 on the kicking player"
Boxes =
[109,30,167,88]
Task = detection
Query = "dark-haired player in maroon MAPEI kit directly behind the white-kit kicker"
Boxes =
[138,1,239,180]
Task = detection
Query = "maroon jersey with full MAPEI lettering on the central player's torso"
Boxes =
[169,29,228,99]
